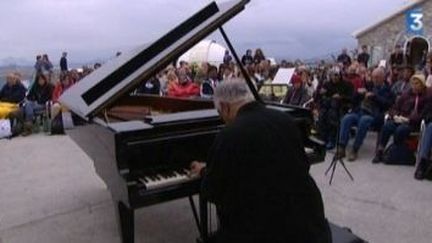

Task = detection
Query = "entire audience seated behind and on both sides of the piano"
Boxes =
[0,47,432,179]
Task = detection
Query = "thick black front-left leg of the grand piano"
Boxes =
[116,202,135,243]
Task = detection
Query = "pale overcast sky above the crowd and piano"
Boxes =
[0,0,407,64]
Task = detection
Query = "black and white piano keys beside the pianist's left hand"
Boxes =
[138,169,199,190]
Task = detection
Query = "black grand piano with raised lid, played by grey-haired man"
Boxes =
[60,0,325,243]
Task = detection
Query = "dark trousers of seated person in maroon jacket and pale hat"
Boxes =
[379,121,412,148]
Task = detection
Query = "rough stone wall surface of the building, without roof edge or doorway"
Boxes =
[357,1,432,64]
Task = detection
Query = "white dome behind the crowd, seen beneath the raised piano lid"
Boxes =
[177,40,227,67]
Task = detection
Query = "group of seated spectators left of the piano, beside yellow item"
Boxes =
[0,64,89,136]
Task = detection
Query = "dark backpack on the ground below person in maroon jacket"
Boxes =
[383,143,416,165]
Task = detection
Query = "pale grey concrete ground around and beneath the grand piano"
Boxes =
[0,135,432,243]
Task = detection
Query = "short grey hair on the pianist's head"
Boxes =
[213,79,255,106]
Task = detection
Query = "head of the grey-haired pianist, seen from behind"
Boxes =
[213,80,255,123]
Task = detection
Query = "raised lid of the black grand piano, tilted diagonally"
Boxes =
[60,0,250,119]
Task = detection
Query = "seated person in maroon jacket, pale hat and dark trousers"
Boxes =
[372,74,431,163]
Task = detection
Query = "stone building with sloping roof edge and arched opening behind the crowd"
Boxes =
[353,0,432,67]
